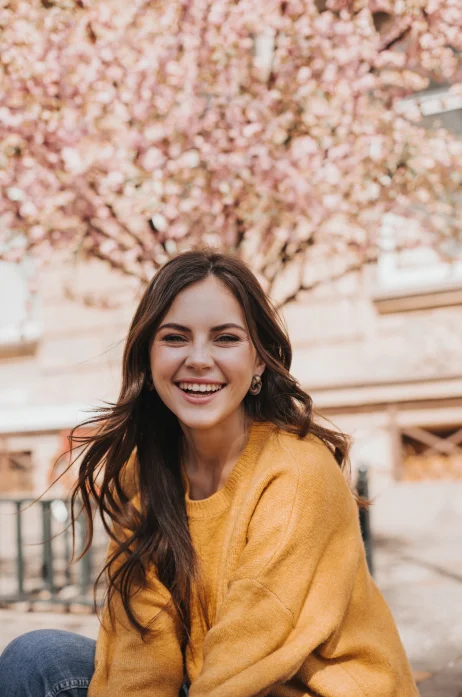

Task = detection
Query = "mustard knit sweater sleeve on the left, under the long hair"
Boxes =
[88,516,184,697]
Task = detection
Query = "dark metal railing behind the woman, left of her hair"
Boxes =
[0,498,106,606]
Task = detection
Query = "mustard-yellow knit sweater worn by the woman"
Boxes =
[88,424,418,697]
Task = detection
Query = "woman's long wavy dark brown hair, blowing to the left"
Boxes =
[70,250,348,636]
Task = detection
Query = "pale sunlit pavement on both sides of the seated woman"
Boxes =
[0,482,462,697]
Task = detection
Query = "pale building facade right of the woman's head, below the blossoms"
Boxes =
[286,250,462,491]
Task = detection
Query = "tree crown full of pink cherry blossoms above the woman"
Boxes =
[0,0,462,302]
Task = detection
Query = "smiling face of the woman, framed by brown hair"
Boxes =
[150,276,264,429]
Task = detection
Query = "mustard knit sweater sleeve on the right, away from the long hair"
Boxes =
[190,443,417,697]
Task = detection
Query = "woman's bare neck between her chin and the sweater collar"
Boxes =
[182,412,248,499]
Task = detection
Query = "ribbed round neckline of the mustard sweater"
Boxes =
[182,421,273,518]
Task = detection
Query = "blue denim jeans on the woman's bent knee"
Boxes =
[0,629,188,697]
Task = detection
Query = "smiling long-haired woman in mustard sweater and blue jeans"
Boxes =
[0,251,418,697]
